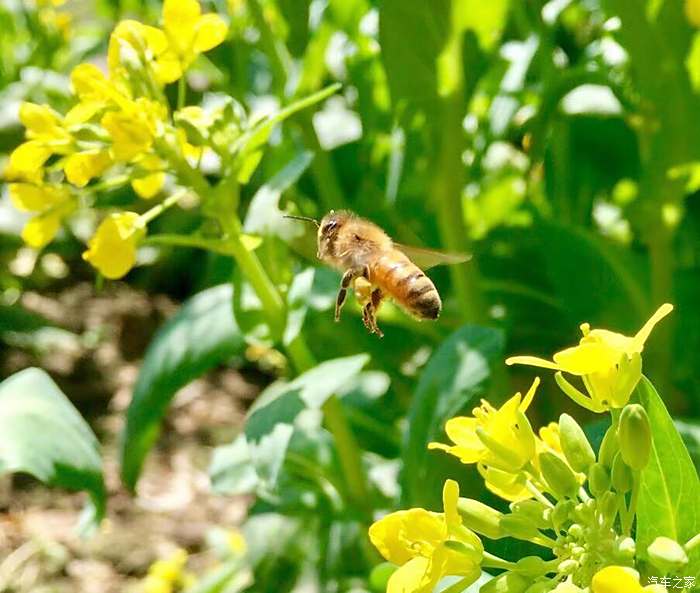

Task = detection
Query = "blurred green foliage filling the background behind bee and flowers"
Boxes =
[0,0,700,591]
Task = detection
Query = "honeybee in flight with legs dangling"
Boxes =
[287,210,469,338]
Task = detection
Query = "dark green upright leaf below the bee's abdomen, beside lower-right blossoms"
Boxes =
[401,325,503,505]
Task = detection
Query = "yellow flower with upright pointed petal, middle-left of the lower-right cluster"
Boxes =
[428,378,540,473]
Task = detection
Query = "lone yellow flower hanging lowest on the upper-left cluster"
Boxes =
[83,212,145,279]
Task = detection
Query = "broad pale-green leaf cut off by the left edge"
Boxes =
[0,368,106,521]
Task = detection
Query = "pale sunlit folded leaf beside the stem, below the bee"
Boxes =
[245,354,369,489]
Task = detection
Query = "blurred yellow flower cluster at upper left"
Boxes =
[4,0,230,278]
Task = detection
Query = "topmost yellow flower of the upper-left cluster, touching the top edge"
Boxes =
[154,0,228,83]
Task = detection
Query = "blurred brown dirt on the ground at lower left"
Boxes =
[0,284,259,593]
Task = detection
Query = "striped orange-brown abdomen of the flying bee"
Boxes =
[370,249,442,319]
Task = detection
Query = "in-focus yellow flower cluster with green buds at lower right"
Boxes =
[369,305,700,593]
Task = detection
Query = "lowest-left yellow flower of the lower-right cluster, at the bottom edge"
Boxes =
[369,480,484,593]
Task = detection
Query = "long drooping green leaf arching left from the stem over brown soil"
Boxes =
[121,284,245,489]
